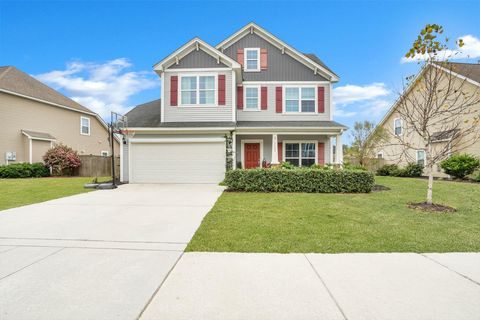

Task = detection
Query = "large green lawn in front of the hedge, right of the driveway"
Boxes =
[187,177,480,253]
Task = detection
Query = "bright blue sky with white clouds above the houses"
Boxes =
[0,0,480,141]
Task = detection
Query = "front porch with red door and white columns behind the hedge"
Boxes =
[233,132,343,169]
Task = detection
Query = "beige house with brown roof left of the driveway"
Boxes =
[0,67,118,164]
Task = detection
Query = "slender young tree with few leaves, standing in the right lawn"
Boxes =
[392,24,480,205]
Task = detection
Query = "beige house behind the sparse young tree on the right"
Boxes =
[375,63,480,177]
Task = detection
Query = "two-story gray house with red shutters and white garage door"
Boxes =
[121,23,346,183]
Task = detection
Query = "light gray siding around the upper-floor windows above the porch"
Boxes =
[237,83,331,121]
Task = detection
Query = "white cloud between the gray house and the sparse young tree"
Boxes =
[333,82,391,118]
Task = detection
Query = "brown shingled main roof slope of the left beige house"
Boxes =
[0,66,94,115]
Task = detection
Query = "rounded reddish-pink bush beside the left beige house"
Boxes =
[43,144,82,175]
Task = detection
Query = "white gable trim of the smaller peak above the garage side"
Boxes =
[153,37,241,73]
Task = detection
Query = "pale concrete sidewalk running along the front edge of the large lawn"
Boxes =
[141,253,480,320]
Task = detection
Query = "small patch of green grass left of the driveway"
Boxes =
[0,177,109,210]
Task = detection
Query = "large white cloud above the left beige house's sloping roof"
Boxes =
[35,58,159,118]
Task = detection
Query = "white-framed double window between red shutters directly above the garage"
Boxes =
[180,76,215,105]
